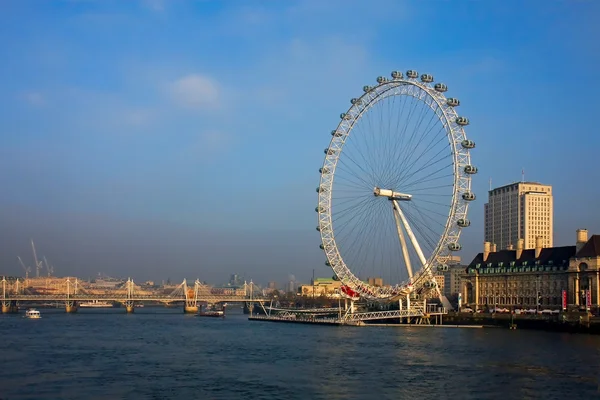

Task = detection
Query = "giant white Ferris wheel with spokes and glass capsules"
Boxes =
[315,70,477,300]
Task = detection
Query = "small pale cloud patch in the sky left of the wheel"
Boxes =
[169,74,221,109]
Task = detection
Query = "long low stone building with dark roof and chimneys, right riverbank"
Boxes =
[461,229,600,310]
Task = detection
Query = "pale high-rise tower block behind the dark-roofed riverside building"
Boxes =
[484,182,554,250]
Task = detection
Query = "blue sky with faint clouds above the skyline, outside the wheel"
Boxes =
[0,0,600,282]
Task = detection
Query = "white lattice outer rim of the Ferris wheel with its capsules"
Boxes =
[316,71,474,299]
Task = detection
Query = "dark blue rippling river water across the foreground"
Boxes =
[0,308,600,400]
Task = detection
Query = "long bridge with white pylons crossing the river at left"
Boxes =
[0,277,267,313]
